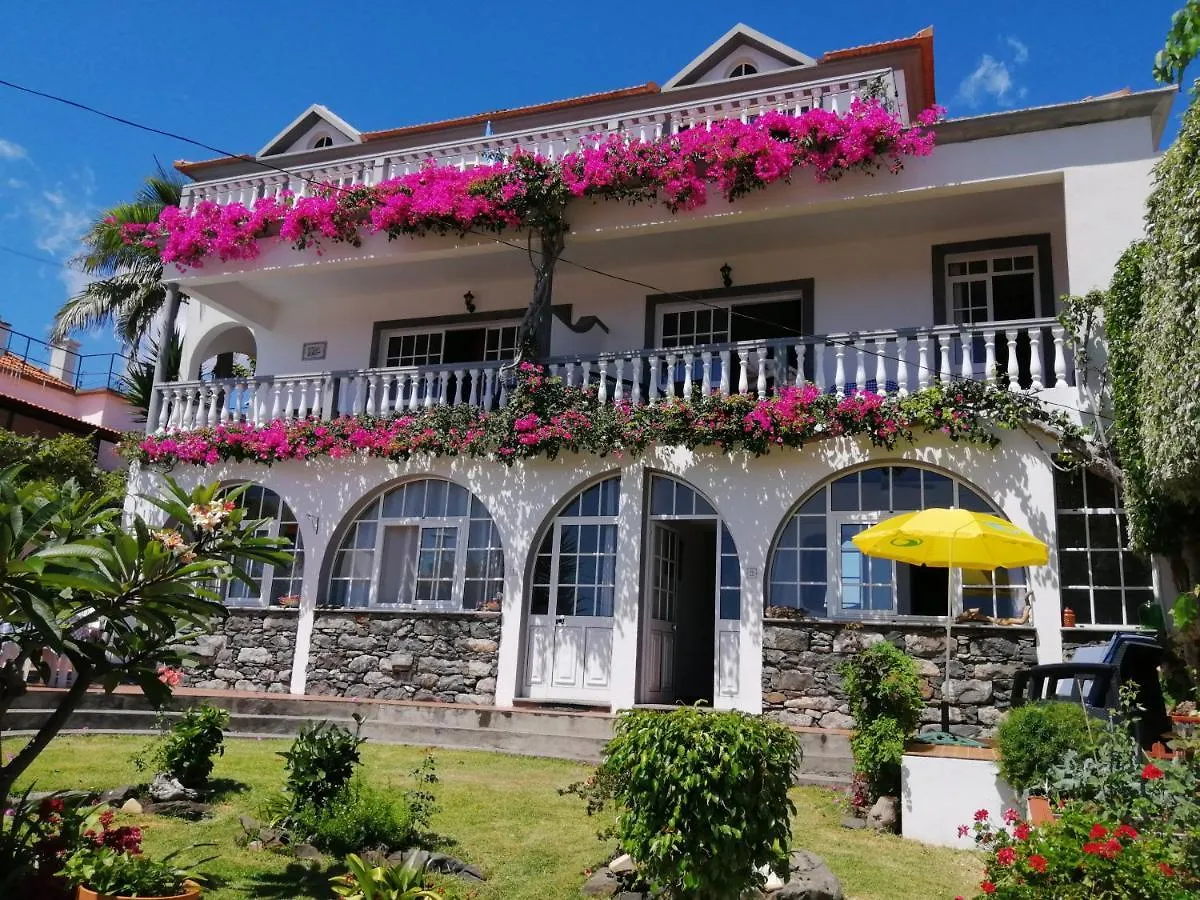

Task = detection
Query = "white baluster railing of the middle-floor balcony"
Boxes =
[148,319,1079,433]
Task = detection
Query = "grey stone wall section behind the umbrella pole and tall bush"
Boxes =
[762,619,1037,737]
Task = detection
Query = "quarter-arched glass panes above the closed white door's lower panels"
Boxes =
[529,475,620,618]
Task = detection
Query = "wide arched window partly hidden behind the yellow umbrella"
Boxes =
[767,466,1026,618]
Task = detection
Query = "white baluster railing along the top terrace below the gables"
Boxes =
[182,68,908,208]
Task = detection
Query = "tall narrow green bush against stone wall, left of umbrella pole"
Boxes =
[839,641,925,805]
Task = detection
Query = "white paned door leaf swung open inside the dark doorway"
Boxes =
[642,522,683,703]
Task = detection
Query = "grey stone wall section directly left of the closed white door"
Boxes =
[306,611,500,704]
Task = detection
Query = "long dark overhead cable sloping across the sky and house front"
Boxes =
[0,78,1111,421]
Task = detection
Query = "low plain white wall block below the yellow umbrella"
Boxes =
[900,754,1022,850]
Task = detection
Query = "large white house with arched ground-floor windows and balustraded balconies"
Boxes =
[131,26,1174,733]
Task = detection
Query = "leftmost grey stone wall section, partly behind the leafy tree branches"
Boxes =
[184,610,298,694]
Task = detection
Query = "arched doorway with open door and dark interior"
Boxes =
[638,473,742,706]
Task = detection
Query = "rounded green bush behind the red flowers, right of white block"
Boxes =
[996,701,1092,792]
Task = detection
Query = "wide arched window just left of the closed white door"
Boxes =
[325,479,504,610]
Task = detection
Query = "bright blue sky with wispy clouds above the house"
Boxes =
[0,0,1182,362]
